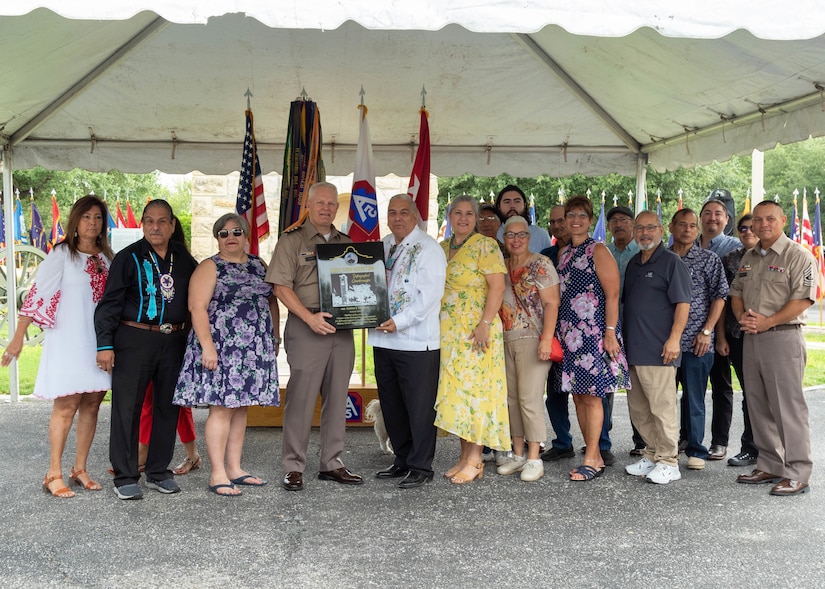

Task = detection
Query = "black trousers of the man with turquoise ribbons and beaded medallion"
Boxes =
[109,325,187,487]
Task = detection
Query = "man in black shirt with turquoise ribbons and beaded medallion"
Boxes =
[95,200,197,499]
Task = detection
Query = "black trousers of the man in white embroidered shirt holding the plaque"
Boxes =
[373,348,441,476]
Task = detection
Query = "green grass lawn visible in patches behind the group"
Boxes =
[6,330,825,392]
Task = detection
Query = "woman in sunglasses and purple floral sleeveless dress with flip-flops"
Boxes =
[174,213,280,496]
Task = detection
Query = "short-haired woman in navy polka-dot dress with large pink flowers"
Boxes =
[558,196,627,481]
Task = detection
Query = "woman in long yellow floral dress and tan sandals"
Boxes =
[435,195,510,484]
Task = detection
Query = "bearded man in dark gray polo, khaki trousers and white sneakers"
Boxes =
[622,211,691,484]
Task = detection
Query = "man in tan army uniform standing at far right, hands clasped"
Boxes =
[730,201,817,496]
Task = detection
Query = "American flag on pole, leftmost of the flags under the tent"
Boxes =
[235,110,269,255]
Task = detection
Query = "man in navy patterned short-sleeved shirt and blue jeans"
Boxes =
[670,208,728,470]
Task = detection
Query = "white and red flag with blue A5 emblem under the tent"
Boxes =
[348,104,381,241]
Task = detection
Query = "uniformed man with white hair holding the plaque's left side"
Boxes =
[266,182,363,491]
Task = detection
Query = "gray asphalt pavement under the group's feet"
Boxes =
[0,389,825,589]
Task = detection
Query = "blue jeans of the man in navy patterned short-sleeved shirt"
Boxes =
[676,352,713,460]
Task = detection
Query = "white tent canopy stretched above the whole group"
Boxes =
[0,0,825,176]
